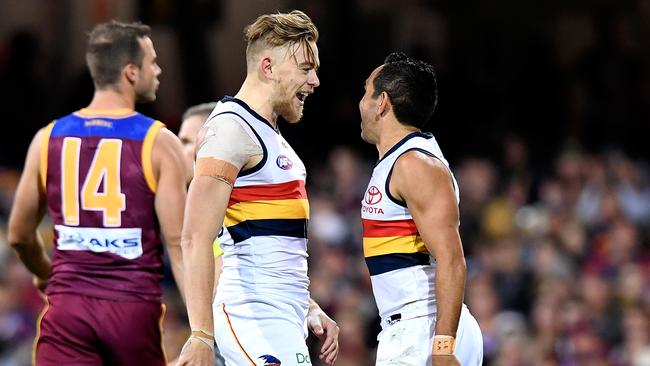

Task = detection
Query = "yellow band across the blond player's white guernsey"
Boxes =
[224,199,309,227]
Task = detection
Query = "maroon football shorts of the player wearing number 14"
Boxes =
[34,294,166,366]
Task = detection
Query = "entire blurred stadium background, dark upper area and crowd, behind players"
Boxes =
[0,0,650,366]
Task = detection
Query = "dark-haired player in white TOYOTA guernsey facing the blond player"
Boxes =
[359,53,483,366]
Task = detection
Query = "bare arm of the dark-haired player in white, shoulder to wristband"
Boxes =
[390,151,466,337]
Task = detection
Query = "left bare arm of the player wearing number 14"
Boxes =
[8,129,50,281]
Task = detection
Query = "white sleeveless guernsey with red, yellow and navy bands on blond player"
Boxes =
[208,97,309,316]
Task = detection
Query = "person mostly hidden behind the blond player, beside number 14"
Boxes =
[178,102,225,366]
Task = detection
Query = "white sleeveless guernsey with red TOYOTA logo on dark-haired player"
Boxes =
[361,132,458,319]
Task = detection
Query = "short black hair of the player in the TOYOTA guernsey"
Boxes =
[373,52,438,128]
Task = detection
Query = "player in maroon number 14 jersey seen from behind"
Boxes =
[9,21,186,365]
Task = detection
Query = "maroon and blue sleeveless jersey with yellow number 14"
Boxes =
[41,109,163,301]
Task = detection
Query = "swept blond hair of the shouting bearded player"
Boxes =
[244,10,318,65]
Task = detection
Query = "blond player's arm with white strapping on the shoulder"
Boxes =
[179,120,261,365]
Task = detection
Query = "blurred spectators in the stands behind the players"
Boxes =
[0,138,650,366]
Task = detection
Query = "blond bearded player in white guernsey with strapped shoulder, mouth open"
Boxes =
[179,11,339,365]
